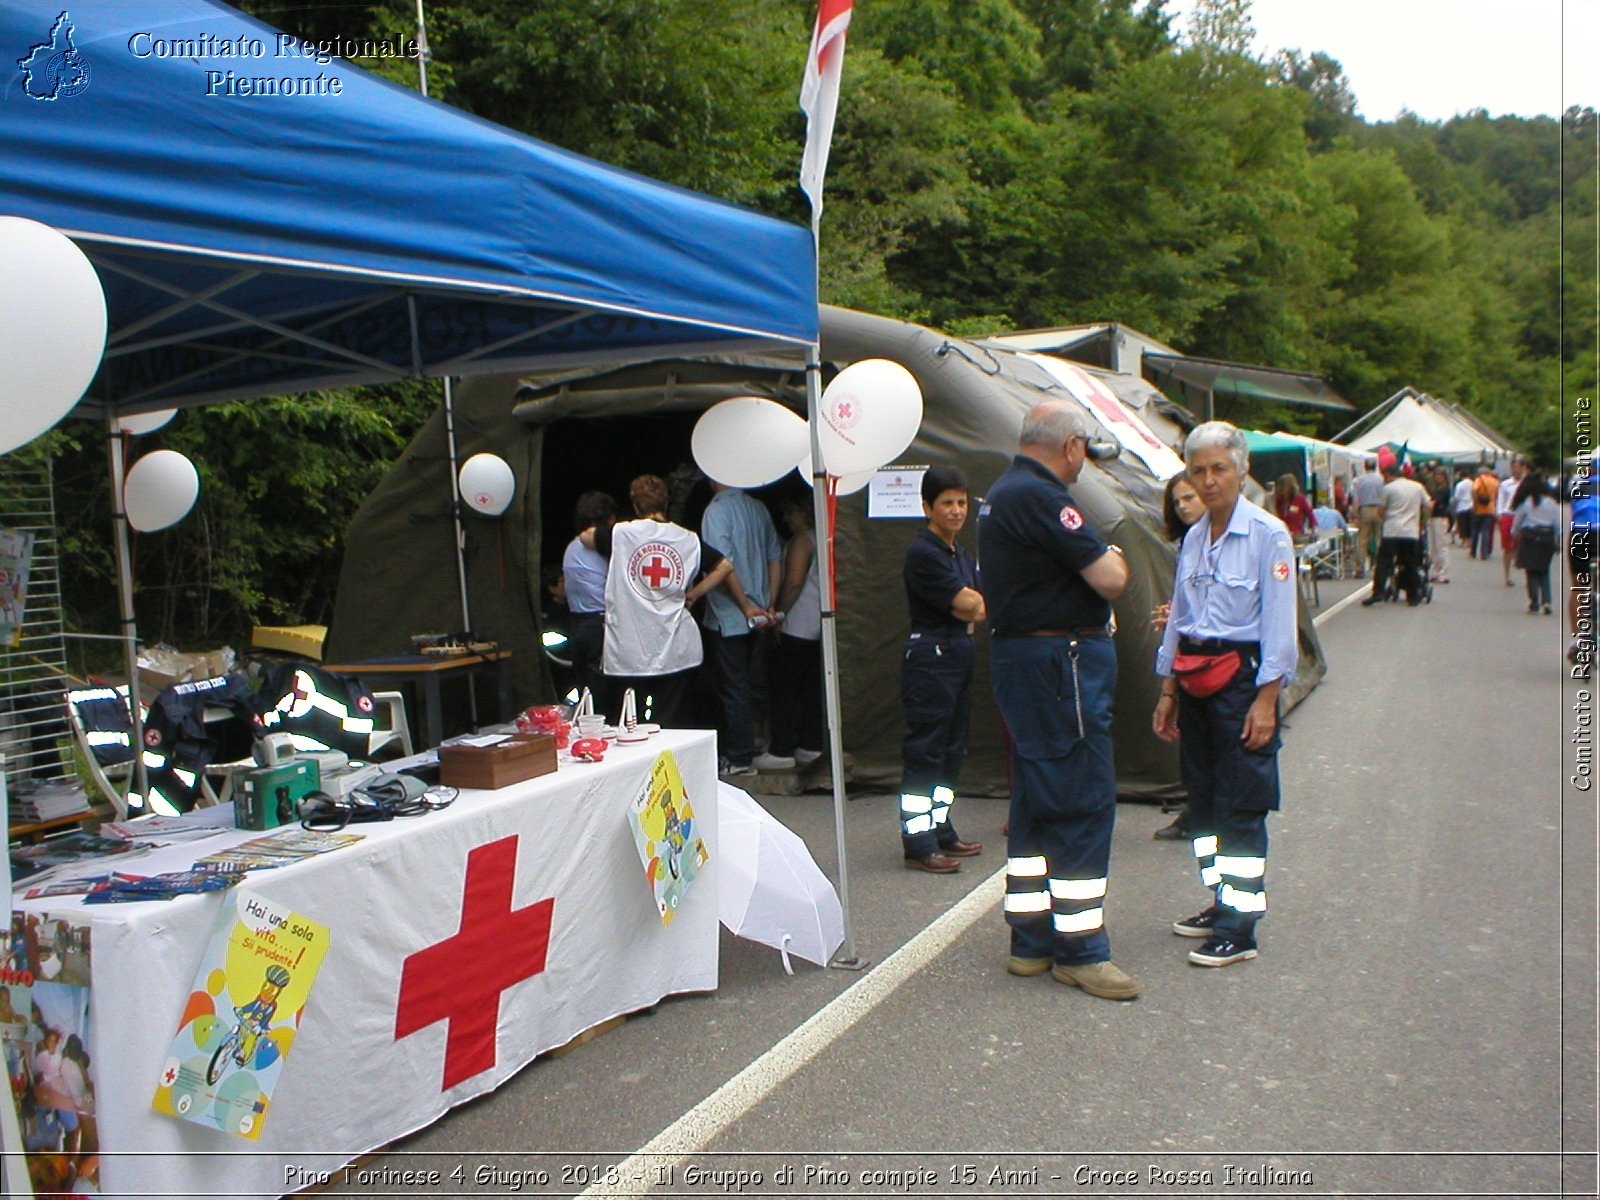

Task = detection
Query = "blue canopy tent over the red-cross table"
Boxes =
[0,0,818,809]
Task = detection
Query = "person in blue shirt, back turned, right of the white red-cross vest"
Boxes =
[701,480,784,776]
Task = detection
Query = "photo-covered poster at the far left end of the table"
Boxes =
[0,912,99,1195]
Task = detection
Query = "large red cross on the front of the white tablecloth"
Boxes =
[395,835,555,1091]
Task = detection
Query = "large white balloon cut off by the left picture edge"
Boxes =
[0,216,106,454]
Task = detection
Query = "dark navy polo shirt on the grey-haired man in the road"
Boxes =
[978,454,1110,637]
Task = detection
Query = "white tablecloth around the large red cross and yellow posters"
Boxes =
[16,731,718,1197]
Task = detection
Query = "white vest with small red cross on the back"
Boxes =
[600,518,702,675]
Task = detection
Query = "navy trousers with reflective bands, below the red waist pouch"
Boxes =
[1178,654,1283,942]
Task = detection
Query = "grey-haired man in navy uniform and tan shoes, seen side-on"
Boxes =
[978,400,1139,1000]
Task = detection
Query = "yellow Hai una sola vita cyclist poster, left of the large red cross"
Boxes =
[150,890,330,1141]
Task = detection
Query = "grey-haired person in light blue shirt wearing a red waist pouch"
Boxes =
[1152,421,1299,966]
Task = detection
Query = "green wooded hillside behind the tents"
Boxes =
[25,0,1597,659]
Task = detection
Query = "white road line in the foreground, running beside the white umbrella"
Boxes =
[581,867,1005,1197]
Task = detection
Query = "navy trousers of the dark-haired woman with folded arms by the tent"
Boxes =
[899,634,973,858]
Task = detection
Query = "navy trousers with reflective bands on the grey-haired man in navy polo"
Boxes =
[990,637,1117,966]
